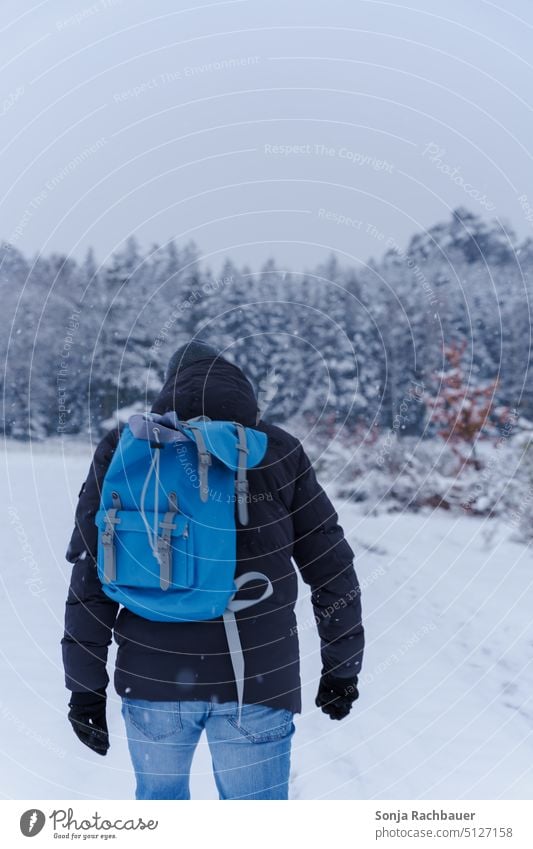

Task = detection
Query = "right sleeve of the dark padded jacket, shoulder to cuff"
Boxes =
[292,445,364,677]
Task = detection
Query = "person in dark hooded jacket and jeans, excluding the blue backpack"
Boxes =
[62,341,364,799]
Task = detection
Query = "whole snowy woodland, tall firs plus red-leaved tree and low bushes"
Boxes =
[0,209,533,540]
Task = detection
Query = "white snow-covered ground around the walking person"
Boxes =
[0,447,533,799]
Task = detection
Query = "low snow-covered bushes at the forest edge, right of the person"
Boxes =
[298,422,533,524]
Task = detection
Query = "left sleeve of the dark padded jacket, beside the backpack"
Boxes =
[61,429,120,692]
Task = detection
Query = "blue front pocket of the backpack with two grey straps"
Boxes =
[96,510,194,590]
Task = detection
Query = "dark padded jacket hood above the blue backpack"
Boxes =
[152,355,257,427]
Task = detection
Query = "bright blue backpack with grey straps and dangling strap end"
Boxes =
[95,412,273,716]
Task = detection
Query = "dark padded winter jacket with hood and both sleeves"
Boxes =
[62,357,364,712]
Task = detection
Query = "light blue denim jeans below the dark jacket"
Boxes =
[122,698,295,799]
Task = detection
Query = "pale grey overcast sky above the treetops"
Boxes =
[0,0,533,269]
